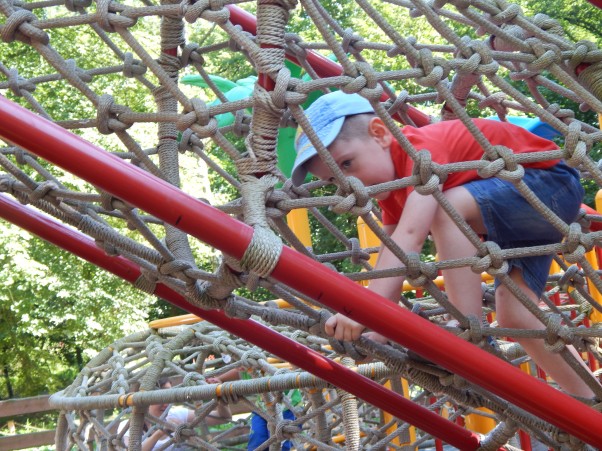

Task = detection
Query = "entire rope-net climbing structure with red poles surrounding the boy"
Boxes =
[0,0,602,450]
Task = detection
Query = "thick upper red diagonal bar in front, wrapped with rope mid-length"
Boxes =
[0,97,602,448]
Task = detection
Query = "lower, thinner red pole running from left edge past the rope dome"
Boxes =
[0,195,479,450]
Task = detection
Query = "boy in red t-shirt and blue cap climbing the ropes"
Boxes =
[291,91,594,398]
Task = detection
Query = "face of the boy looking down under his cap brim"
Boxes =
[306,135,397,200]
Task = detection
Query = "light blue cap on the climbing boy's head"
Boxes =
[291,91,374,186]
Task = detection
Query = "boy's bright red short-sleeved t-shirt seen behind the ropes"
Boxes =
[378,119,559,225]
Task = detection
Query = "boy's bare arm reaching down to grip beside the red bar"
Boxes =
[325,191,438,341]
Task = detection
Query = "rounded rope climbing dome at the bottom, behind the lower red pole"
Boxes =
[55,319,422,450]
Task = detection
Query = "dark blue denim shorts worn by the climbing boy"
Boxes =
[463,161,584,296]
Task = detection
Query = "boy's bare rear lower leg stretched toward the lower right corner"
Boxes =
[495,268,594,398]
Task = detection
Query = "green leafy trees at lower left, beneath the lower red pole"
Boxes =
[0,223,154,398]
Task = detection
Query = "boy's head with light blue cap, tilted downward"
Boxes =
[291,91,396,195]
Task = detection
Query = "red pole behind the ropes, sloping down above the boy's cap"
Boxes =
[226,5,431,127]
